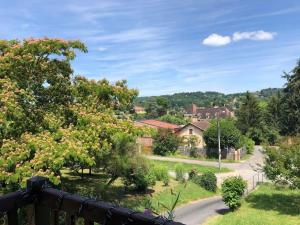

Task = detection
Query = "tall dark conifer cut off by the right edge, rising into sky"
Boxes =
[280,60,300,135]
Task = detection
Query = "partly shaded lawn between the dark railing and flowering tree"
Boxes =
[62,170,215,213]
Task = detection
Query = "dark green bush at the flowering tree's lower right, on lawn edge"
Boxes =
[124,157,156,191]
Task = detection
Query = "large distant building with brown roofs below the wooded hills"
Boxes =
[185,104,234,121]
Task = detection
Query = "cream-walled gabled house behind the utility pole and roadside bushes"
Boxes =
[176,120,210,149]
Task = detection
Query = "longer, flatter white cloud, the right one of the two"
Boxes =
[232,30,276,41]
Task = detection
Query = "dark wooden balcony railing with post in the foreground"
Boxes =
[0,177,182,225]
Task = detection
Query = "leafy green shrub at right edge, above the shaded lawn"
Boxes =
[264,137,300,188]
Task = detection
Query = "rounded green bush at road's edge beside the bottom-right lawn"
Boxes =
[222,176,247,210]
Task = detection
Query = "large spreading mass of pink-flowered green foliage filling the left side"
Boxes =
[0,38,148,187]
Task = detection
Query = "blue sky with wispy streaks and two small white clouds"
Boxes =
[0,0,300,96]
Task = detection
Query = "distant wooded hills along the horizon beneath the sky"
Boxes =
[135,88,282,109]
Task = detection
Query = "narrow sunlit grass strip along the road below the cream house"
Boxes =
[151,160,231,173]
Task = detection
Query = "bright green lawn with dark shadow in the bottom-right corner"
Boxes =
[206,184,300,225]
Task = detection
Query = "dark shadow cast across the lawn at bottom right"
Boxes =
[246,190,300,216]
